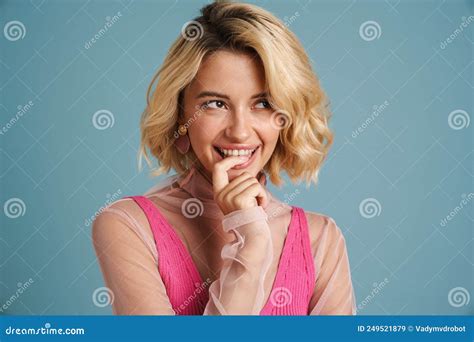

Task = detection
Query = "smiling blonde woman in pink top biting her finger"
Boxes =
[93,2,355,315]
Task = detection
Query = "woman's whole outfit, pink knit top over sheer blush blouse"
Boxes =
[92,168,356,316]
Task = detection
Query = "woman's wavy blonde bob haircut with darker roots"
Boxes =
[139,1,333,186]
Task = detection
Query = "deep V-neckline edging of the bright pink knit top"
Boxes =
[149,197,297,315]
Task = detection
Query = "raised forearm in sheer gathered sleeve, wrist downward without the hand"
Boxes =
[204,206,273,315]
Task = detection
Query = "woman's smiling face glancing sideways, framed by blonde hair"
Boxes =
[180,51,279,180]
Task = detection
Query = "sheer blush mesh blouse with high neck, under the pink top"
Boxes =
[92,168,356,315]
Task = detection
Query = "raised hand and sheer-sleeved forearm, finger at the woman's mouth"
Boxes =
[204,156,273,315]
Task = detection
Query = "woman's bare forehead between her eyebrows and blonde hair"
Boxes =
[189,51,265,96]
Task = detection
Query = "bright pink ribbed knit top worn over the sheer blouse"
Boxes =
[126,196,315,316]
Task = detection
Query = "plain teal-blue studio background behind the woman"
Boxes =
[0,0,474,315]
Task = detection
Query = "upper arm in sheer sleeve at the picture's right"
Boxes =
[307,213,356,315]
